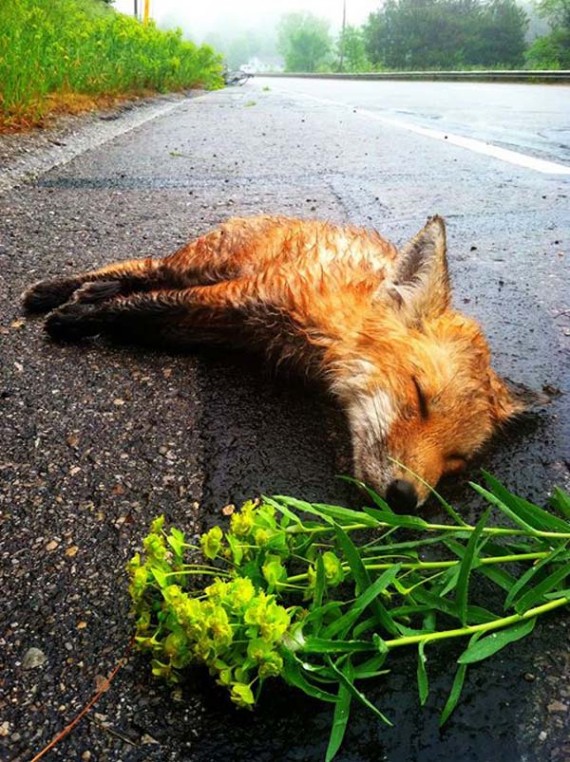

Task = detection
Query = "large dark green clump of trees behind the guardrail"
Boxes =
[363,0,528,70]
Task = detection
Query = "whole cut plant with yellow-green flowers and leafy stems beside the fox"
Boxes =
[129,474,570,760]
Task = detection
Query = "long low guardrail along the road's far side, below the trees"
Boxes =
[254,69,570,85]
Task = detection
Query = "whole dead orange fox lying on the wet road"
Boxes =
[23,216,528,511]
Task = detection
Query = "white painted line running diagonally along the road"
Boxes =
[288,90,570,175]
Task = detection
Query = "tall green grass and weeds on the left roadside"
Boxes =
[0,0,221,127]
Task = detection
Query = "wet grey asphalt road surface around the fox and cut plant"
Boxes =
[0,80,570,762]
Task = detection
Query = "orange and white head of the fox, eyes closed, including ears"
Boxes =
[336,217,532,511]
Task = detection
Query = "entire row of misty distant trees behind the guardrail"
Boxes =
[277,0,570,72]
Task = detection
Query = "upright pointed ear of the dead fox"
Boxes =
[388,216,451,321]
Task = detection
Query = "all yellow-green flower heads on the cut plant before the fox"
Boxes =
[129,501,344,707]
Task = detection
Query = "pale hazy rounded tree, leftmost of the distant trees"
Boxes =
[277,12,332,71]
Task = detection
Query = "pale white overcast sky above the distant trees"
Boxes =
[115,0,381,39]
